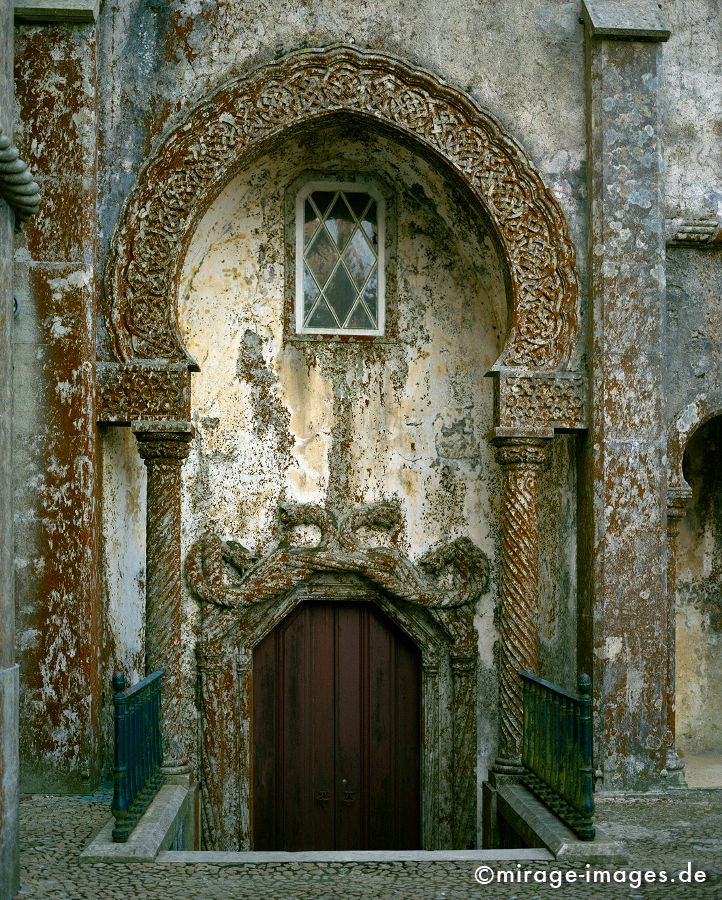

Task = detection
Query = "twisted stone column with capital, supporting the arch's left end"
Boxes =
[133,421,193,775]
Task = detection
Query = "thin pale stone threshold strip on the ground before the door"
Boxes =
[155,848,554,866]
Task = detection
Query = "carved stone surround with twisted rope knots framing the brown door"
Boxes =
[186,504,489,850]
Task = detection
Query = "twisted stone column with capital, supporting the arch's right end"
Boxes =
[493,436,550,774]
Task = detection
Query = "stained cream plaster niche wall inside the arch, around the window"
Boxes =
[178,116,506,555]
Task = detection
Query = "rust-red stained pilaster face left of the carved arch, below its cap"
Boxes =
[14,25,100,791]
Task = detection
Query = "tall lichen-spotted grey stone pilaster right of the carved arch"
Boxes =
[579,0,669,789]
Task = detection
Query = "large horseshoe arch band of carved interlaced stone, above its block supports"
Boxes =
[107,46,579,380]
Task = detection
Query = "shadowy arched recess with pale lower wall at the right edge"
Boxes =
[677,417,722,754]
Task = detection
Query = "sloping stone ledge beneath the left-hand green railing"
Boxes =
[80,784,197,862]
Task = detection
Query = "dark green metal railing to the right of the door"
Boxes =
[520,672,594,841]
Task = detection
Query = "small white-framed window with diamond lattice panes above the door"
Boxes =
[296,181,386,335]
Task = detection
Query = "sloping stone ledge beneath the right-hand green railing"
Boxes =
[496,784,628,865]
